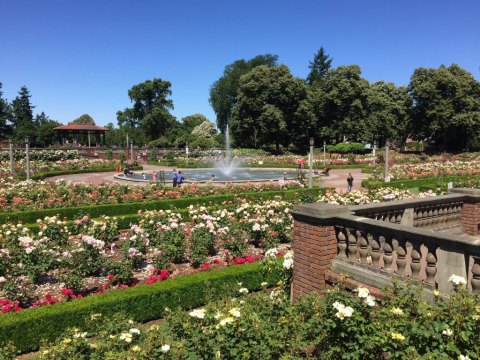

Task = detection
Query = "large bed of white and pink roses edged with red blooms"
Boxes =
[0,199,292,312]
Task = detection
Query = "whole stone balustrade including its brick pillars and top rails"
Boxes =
[292,191,480,298]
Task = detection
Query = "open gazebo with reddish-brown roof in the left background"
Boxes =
[53,122,108,147]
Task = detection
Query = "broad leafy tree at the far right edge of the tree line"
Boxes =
[408,64,480,150]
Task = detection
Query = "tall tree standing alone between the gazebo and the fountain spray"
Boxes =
[117,78,176,140]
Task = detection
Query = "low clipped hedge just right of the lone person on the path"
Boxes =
[362,175,478,190]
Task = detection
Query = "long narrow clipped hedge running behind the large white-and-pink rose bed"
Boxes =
[0,188,325,224]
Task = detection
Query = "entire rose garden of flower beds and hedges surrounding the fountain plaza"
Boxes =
[0,147,480,359]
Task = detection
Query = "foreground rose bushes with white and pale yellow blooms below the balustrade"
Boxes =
[5,276,480,360]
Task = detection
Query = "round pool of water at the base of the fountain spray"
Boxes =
[114,168,307,183]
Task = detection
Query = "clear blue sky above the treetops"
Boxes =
[0,0,480,125]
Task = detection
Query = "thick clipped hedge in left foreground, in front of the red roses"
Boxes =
[0,263,276,353]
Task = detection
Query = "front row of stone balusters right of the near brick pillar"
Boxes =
[334,214,480,293]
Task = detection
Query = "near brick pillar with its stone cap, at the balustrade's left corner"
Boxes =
[292,204,348,300]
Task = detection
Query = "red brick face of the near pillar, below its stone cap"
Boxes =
[292,220,337,300]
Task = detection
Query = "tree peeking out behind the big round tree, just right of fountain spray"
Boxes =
[209,54,278,133]
